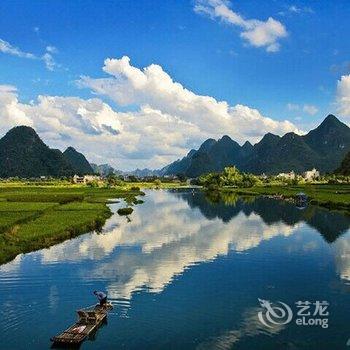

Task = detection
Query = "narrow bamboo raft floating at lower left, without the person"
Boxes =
[51,303,113,346]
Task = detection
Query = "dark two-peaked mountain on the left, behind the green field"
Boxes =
[0,126,92,178]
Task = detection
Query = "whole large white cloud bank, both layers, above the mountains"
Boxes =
[0,56,298,169]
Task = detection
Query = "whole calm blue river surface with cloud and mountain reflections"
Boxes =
[0,190,350,350]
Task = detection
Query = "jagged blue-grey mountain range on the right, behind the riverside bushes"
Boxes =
[160,114,350,177]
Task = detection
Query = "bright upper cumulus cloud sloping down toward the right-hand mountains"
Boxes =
[78,56,297,142]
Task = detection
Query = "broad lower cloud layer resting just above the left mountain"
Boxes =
[0,85,202,169]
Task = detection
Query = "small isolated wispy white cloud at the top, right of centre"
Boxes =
[194,0,288,52]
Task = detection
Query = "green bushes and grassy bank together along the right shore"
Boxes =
[198,167,350,215]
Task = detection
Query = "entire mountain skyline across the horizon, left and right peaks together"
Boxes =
[0,114,350,178]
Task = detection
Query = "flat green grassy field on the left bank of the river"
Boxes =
[0,185,143,264]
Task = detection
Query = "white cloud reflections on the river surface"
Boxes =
[2,191,350,300]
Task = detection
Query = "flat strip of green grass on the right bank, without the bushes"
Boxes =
[223,184,350,214]
